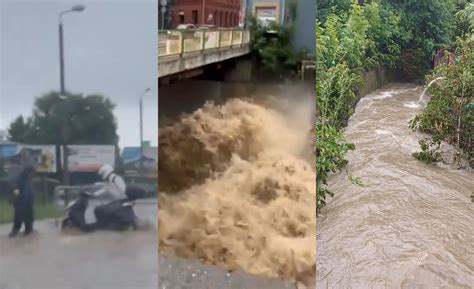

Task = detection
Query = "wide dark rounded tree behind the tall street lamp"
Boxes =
[8,92,118,145]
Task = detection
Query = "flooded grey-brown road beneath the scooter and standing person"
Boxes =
[0,200,158,289]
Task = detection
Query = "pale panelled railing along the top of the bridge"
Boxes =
[158,28,250,57]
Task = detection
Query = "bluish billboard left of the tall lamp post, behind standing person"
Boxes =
[0,144,56,173]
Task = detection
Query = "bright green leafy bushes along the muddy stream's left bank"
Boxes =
[316,1,406,211]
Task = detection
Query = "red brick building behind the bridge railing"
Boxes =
[172,0,241,28]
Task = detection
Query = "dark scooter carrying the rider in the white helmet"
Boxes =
[61,186,146,232]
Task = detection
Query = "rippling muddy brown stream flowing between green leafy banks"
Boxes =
[317,84,474,288]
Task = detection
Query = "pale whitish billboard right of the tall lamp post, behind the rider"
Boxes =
[61,145,115,172]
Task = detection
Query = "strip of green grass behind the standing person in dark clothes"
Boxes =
[0,198,63,224]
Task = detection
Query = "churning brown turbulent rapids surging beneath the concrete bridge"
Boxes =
[159,99,316,285]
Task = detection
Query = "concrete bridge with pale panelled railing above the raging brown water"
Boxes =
[158,28,250,81]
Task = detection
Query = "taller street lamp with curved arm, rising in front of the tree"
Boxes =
[59,5,86,185]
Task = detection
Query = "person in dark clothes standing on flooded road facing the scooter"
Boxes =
[10,167,35,237]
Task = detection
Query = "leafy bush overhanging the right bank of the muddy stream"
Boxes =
[410,36,474,167]
